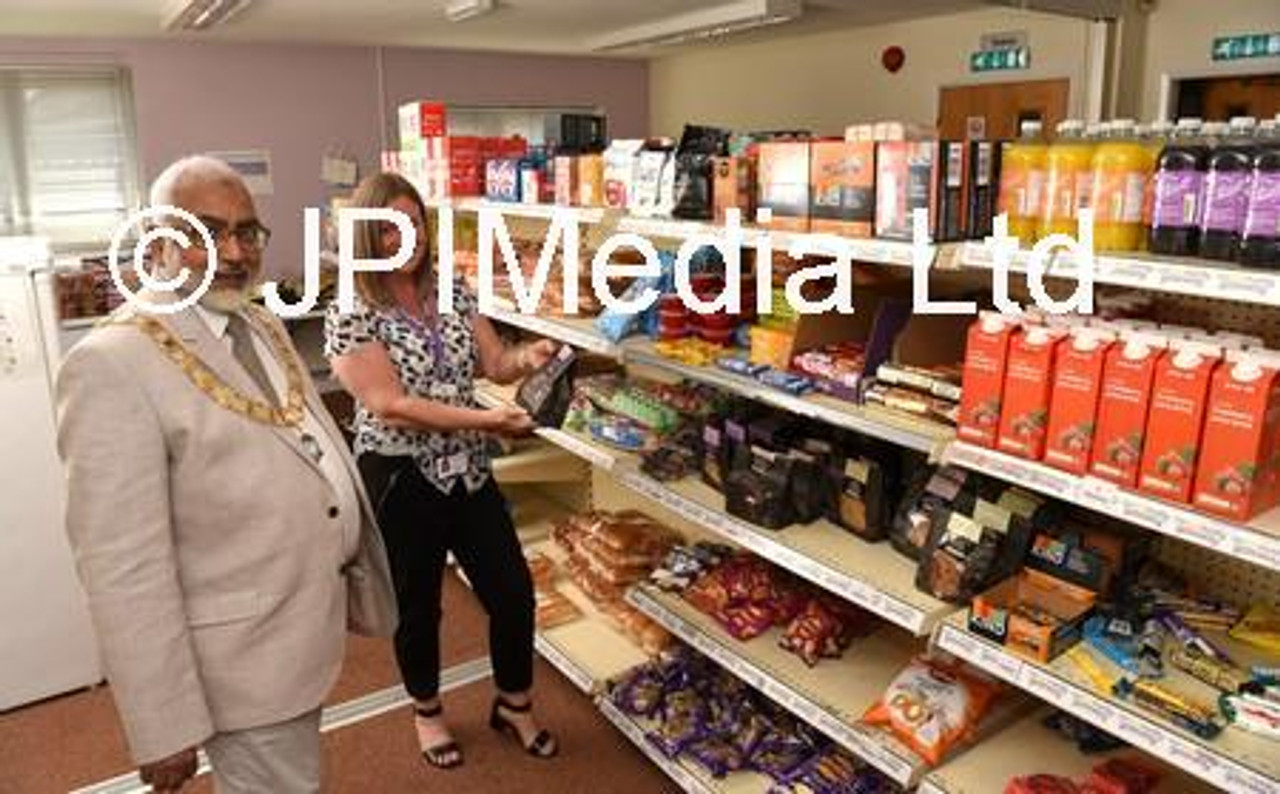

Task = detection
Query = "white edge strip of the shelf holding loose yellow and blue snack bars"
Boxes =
[938,625,1280,794]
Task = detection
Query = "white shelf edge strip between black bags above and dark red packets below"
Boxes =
[618,471,932,636]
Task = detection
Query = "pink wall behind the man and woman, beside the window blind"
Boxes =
[0,37,649,274]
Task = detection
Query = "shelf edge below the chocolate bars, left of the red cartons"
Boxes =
[622,339,954,455]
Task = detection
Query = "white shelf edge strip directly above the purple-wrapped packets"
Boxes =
[627,589,923,786]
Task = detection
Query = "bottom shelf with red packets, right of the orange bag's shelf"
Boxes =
[916,709,1216,794]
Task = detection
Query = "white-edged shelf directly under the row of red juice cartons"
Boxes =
[943,442,1280,571]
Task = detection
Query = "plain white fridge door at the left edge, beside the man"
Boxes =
[0,239,101,711]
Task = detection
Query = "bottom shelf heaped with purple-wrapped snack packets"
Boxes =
[599,645,893,793]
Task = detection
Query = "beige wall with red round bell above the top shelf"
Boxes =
[649,7,1090,136]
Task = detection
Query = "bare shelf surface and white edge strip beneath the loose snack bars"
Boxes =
[937,613,1280,794]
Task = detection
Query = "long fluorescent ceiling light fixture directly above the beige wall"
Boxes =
[590,0,803,53]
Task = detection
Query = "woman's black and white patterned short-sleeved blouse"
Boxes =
[325,280,490,493]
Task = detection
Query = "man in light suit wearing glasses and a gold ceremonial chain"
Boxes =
[58,158,396,794]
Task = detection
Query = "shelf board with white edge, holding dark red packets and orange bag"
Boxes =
[627,585,925,786]
